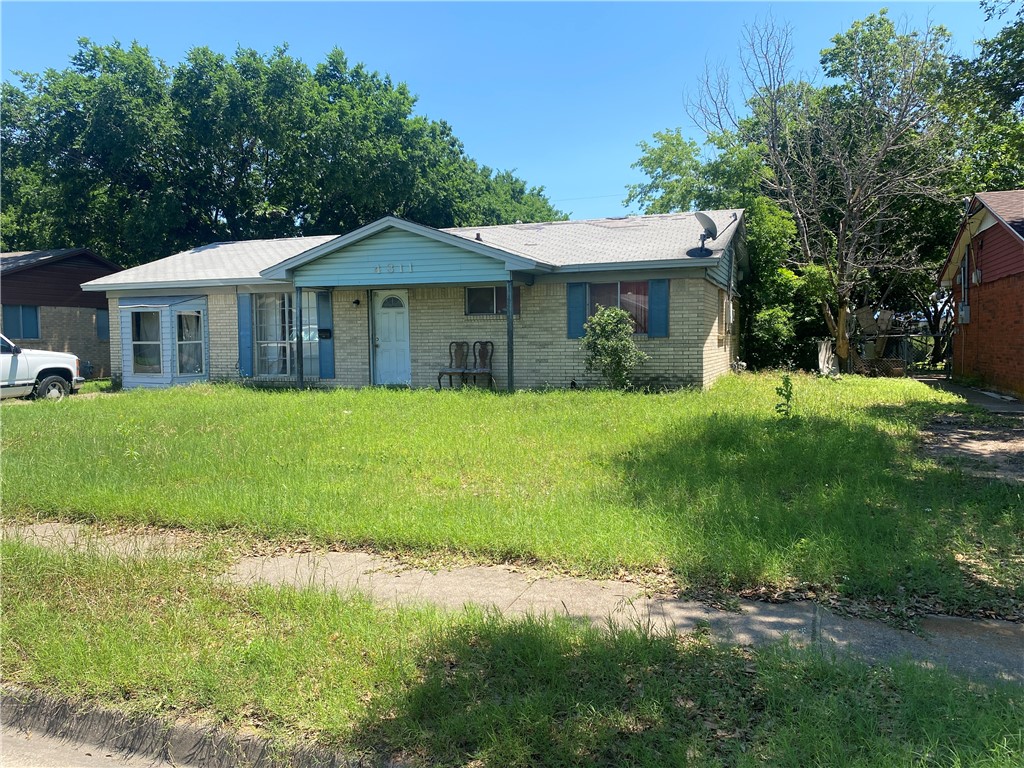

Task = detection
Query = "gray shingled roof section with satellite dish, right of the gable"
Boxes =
[442,208,742,267]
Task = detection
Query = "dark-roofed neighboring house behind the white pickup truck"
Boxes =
[0,248,122,378]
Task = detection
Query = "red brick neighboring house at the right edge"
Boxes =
[940,189,1024,397]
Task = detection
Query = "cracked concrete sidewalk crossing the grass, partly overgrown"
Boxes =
[3,523,1024,684]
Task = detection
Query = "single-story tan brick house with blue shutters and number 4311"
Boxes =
[83,210,745,389]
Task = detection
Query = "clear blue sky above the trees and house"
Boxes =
[0,0,999,218]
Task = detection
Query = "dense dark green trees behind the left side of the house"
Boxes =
[0,40,564,265]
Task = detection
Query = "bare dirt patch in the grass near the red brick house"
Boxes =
[921,415,1024,483]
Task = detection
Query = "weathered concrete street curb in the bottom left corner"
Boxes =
[0,686,376,768]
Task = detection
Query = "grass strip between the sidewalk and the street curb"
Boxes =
[0,541,1024,768]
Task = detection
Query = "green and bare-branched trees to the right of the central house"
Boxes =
[628,11,1024,366]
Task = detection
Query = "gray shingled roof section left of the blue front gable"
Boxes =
[85,234,337,290]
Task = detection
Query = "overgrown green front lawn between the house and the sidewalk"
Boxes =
[2,375,1024,615]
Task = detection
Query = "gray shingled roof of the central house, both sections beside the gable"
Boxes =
[85,209,742,290]
